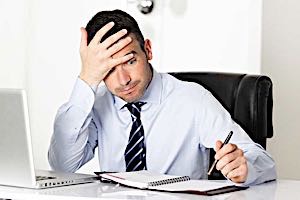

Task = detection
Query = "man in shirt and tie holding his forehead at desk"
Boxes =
[49,10,276,185]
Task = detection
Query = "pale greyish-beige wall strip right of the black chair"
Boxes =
[262,0,300,180]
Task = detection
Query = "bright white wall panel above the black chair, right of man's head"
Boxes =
[127,0,262,74]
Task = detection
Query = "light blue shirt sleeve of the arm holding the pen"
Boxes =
[198,91,276,185]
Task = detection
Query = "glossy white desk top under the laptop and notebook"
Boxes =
[0,180,300,200]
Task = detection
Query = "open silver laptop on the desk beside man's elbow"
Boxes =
[0,89,96,188]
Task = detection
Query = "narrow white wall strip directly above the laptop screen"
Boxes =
[0,0,26,88]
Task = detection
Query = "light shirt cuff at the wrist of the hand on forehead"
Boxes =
[69,78,97,113]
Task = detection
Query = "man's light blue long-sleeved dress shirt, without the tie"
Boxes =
[48,71,276,185]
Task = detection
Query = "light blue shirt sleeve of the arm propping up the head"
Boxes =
[48,78,97,172]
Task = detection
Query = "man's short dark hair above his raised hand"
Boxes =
[85,10,145,51]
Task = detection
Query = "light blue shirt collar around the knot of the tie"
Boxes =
[113,69,162,110]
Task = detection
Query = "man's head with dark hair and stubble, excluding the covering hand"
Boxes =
[86,10,152,102]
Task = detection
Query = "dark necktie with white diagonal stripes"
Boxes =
[124,102,147,172]
